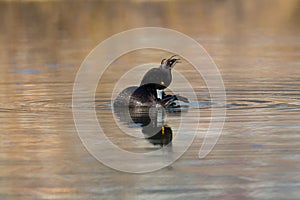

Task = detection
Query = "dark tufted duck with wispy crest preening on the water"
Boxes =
[113,55,188,108]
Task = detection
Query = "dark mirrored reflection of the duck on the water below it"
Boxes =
[114,106,173,146]
